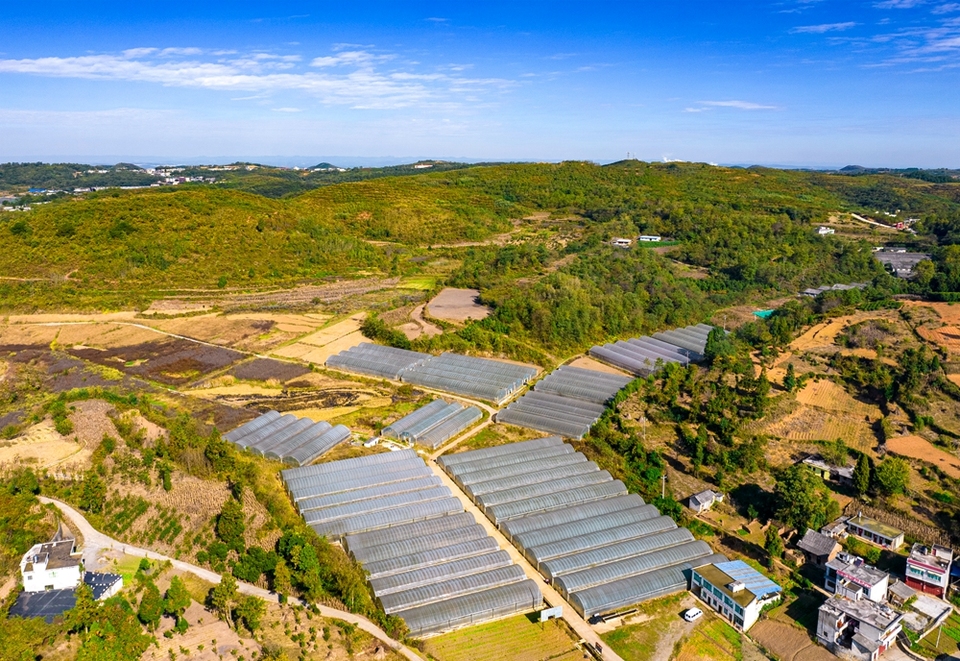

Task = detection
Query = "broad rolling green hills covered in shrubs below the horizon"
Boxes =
[0,161,960,309]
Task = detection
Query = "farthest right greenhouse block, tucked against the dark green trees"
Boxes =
[589,324,714,376]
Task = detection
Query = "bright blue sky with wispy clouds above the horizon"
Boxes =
[0,0,960,167]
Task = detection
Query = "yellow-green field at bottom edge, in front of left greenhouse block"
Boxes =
[425,614,583,661]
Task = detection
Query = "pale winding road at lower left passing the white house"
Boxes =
[40,496,423,661]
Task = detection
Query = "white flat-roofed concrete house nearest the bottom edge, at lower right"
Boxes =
[817,597,903,661]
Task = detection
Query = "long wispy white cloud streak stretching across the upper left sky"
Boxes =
[0,44,515,111]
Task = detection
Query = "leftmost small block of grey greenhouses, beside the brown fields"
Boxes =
[223,411,350,466]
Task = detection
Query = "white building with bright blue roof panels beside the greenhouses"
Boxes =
[690,560,783,631]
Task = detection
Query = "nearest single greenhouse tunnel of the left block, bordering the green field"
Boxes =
[396,581,543,636]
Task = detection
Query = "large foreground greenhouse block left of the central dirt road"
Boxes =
[281,450,543,637]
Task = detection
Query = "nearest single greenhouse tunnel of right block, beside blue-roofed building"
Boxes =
[569,554,727,618]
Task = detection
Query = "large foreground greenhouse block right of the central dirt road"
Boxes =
[438,437,726,617]
